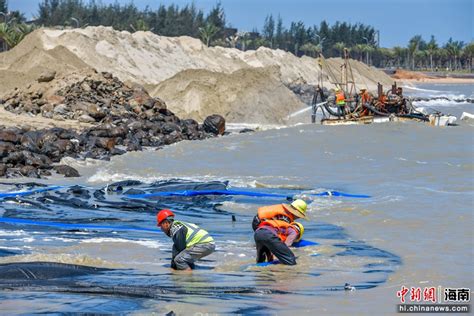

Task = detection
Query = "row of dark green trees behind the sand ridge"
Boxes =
[0,0,474,71]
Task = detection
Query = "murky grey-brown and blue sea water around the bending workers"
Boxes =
[0,85,474,315]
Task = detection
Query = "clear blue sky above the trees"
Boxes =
[5,0,474,47]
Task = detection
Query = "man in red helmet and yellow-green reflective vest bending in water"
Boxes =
[156,210,216,270]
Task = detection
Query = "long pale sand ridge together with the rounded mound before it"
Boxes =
[0,27,392,123]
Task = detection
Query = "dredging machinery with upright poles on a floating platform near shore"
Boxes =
[311,49,456,126]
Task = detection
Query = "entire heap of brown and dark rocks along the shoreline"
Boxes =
[0,73,225,177]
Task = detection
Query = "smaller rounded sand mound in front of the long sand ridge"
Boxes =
[151,67,304,123]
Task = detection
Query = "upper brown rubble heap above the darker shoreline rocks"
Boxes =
[3,72,171,123]
